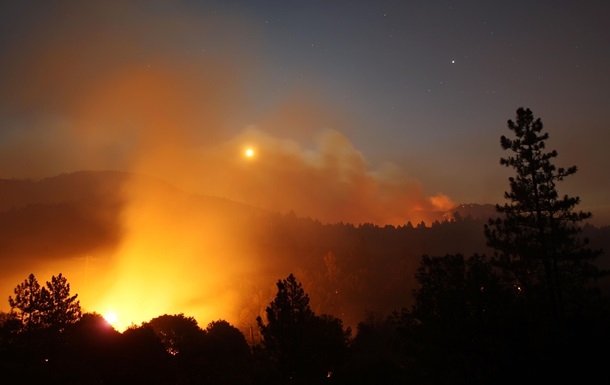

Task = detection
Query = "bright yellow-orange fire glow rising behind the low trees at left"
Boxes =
[82,174,255,332]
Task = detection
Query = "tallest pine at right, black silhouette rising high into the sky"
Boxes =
[484,108,610,382]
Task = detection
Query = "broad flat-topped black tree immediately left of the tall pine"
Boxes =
[393,254,521,384]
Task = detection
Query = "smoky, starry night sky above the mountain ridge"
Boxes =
[0,0,610,223]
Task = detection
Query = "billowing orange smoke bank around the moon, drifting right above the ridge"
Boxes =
[185,128,451,225]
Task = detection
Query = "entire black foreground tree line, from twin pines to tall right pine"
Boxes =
[0,108,610,384]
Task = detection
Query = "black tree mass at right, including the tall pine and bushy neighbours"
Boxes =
[344,108,610,384]
